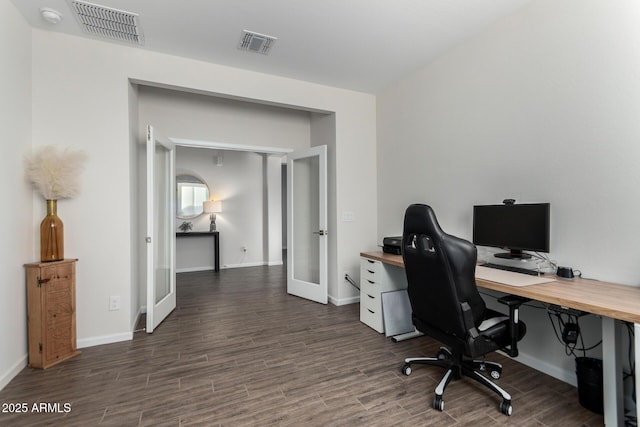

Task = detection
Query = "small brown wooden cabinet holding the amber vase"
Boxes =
[25,259,80,369]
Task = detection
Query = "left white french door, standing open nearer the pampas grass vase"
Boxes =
[146,126,176,333]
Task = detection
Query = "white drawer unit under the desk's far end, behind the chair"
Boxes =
[360,257,407,333]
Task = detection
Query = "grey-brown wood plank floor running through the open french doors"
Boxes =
[0,267,603,427]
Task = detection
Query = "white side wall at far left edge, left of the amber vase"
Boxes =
[0,2,32,389]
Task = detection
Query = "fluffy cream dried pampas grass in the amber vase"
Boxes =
[24,145,87,200]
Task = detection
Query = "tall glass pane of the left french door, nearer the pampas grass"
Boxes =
[153,144,173,303]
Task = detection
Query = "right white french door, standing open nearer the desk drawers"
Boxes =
[287,145,328,304]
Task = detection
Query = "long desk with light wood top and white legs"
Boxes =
[360,252,640,426]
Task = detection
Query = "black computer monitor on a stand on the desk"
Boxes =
[473,203,551,259]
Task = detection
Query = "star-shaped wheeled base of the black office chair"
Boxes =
[402,347,513,415]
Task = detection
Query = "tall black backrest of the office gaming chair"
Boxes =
[402,204,486,338]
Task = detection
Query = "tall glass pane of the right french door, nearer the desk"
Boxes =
[288,156,320,284]
